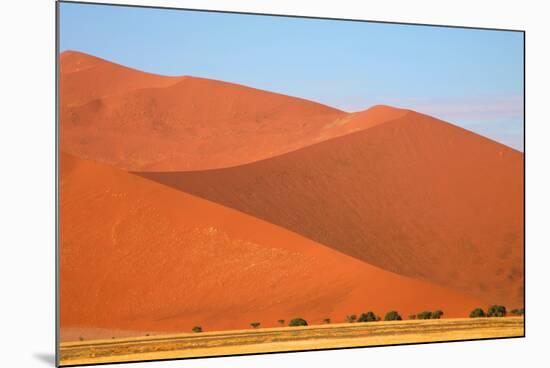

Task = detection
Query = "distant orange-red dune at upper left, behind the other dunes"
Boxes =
[60,52,366,171]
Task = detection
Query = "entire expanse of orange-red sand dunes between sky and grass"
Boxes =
[60,51,524,353]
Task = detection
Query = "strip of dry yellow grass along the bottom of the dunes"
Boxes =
[60,317,524,366]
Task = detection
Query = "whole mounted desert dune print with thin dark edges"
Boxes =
[57,1,525,366]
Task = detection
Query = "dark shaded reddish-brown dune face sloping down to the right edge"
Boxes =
[142,108,523,307]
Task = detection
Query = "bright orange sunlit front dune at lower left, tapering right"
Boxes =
[60,153,483,339]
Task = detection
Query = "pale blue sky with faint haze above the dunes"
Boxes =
[60,3,523,150]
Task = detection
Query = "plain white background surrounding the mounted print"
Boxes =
[0,0,550,368]
